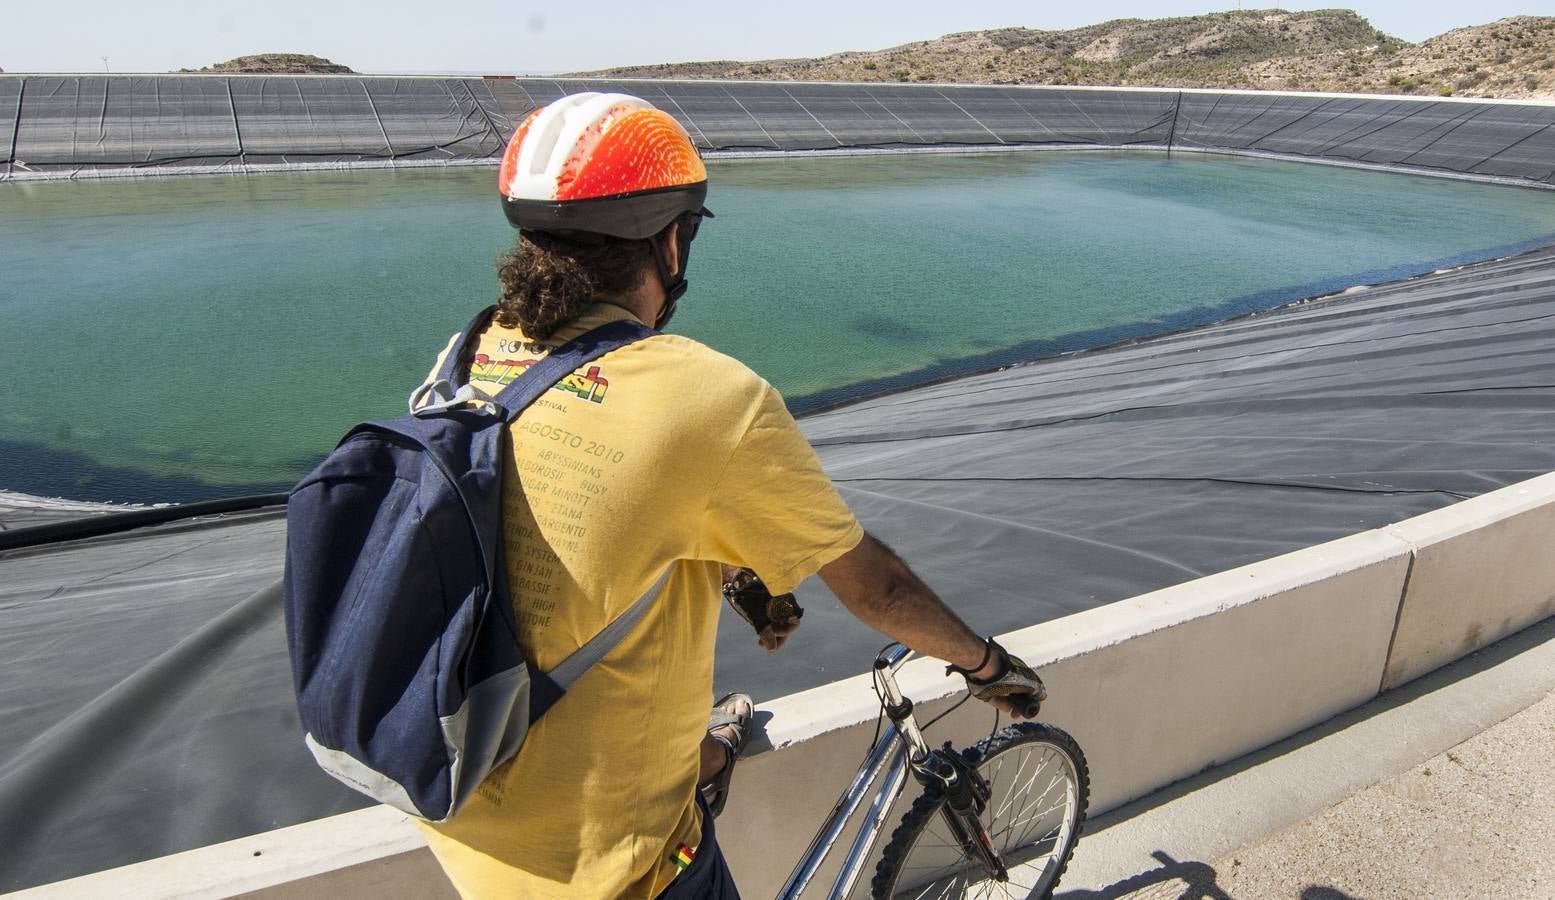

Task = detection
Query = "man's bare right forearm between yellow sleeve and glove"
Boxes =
[821,535,1001,678]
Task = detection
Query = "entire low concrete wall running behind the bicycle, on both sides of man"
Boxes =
[19,474,1555,900]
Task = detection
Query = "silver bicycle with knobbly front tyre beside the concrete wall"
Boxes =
[778,644,1090,900]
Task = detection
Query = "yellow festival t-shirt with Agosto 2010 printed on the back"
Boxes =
[423,303,863,898]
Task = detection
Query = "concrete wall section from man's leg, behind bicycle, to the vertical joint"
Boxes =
[718,532,1409,897]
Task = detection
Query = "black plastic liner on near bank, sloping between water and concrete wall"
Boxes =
[0,249,1555,889]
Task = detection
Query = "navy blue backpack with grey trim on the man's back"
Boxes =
[285,309,664,822]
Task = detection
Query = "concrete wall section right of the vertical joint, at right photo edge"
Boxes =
[1382,474,1555,690]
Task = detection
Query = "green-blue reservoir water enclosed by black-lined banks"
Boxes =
[9,152,1555,502]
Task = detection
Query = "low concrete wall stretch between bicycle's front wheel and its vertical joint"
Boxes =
[1008,532,1409,813]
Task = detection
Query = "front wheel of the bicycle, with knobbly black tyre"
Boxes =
[871,721,1090,900]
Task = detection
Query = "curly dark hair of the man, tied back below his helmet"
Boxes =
[496,230,653,340]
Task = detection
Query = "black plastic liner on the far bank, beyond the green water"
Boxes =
[0,75,1555,185]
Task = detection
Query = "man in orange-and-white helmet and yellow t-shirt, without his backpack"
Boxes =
[423,93,1042,898]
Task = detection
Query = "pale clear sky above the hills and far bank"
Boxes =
[0,0,1552,73]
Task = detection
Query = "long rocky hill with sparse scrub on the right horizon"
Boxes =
[585,9,1555,99]
